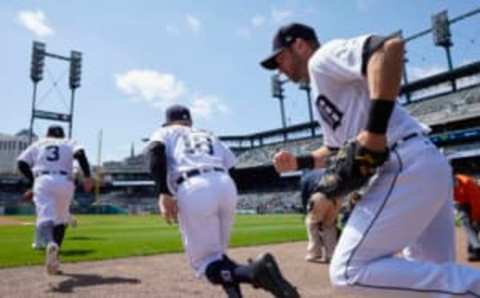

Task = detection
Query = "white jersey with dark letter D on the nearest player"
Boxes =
[308,35,423,147]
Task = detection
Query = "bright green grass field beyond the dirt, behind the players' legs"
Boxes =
[0,215,306,268]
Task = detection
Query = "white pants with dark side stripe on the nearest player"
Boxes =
[330,137,480,297]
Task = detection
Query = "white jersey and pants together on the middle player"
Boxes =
[150,125,237,276]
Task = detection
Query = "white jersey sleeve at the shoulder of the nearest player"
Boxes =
[309,35,370,82]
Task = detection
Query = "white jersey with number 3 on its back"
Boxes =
[17,138,83,176]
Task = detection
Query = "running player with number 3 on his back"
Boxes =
[17,125,93,274]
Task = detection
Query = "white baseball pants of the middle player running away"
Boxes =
[176,171,237,277]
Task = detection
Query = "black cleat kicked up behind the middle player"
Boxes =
[252,253,300,298]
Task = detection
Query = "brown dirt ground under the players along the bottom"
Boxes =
[0,229,480,298]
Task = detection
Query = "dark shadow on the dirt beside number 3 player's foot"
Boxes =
[49,273,141,293]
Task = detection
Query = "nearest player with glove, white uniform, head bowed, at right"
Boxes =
[261,23,480,297]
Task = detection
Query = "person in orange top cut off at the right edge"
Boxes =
[454,174,480,261]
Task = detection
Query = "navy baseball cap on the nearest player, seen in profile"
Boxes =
[260,23,318,70]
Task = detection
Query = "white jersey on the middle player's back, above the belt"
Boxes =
[150,125,236,193]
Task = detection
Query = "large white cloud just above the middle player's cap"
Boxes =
[115,69,187,107]
